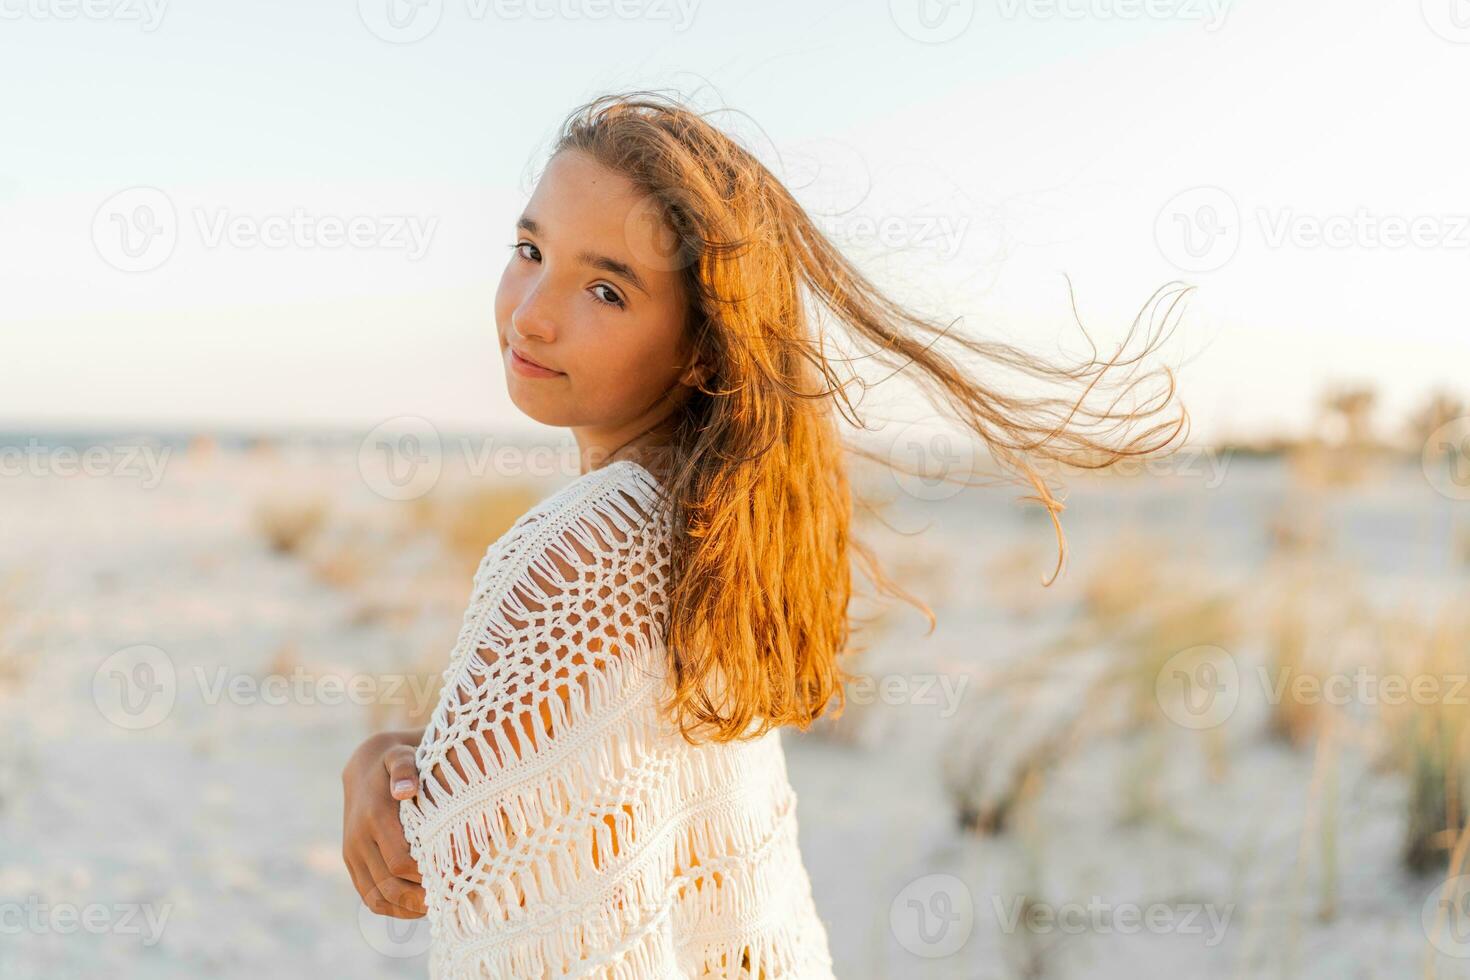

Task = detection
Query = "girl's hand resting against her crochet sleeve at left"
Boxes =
[343,729,423,918]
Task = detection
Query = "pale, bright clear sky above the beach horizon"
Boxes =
[0,0,1470,436]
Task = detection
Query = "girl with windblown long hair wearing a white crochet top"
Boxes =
[344,94,1185,980]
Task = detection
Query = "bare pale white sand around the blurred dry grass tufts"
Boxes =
[0,443,1470,980]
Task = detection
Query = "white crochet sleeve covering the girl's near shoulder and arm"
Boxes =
[400,467,667,976]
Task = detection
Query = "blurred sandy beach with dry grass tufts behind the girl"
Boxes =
[0,442,1470,980]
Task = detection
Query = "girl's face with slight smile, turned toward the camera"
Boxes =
[495,151,695,453]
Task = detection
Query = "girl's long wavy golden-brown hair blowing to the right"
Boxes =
[551,93,1189,742]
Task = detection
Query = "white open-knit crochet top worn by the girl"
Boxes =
[400,460,832,980]
